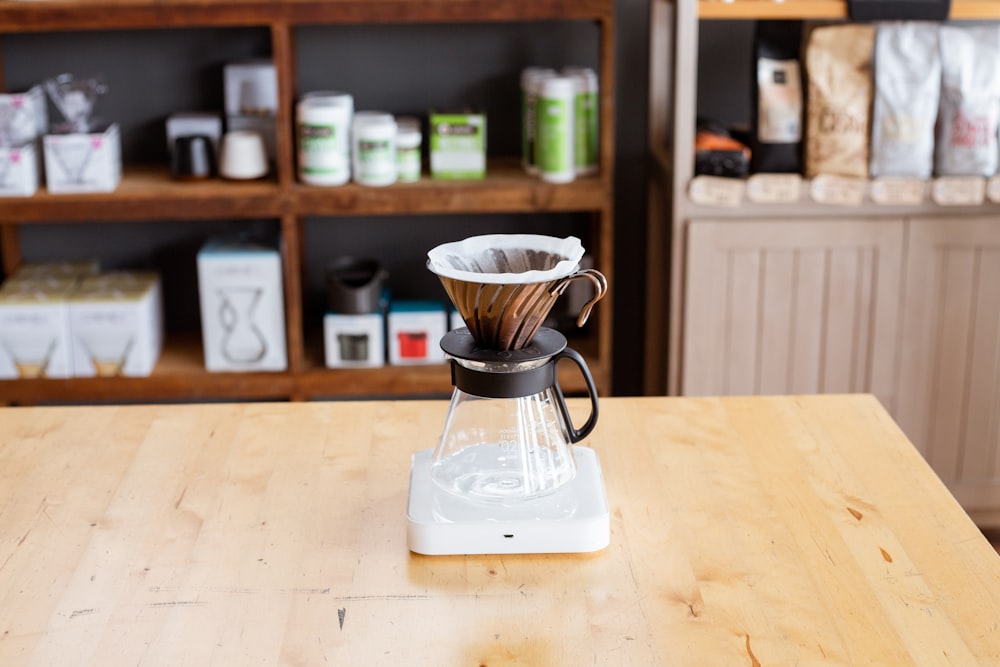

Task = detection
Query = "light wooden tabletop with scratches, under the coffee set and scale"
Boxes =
[0,396,1000,667]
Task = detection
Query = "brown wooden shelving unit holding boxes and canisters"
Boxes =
[0,0,615,402]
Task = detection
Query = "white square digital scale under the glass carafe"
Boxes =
[406,445,611,556]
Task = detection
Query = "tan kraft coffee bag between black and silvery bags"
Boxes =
[805,24,875,178]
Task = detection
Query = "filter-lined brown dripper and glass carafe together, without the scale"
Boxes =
[428,235,607,502]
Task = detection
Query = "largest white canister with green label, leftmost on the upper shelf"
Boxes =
[296,92,354,185]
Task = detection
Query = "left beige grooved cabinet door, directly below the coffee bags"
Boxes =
[682,220,903,410]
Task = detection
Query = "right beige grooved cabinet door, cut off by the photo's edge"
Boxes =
[897,219,1000,511]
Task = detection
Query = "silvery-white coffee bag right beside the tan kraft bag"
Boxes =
[871,21,941,178]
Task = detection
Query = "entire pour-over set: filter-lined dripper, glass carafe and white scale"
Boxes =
[407,234,610,555]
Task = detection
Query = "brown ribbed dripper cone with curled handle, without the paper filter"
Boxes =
[438,269,607,350]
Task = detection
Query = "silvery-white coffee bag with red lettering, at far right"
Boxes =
[934,25,1000,176]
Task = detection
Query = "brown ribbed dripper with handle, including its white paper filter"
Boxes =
[428,235,608,350]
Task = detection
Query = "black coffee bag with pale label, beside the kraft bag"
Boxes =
[750,21,803,173]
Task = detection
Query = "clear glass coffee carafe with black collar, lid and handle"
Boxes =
[431,328,598,503]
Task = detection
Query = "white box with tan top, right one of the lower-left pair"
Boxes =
[69,273,163,377]
